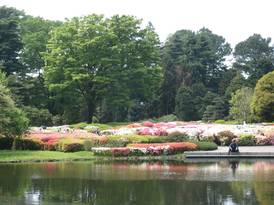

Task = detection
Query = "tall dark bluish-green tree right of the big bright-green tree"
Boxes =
[162,28,231,114]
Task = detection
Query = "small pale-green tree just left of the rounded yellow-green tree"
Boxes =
[229,87,253,122]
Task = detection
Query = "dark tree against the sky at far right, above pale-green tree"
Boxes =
[234,34,274,87]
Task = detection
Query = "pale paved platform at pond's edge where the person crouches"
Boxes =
[185,146,274,158]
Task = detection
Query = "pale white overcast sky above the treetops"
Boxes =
[0,0,274,46]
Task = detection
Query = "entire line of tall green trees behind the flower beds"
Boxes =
[0,6,274,133]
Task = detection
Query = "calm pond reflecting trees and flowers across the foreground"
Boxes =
[0,160,274,205]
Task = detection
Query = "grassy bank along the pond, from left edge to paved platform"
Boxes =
[0,150,184,163]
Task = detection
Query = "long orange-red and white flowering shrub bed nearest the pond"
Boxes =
[92,142,198,157]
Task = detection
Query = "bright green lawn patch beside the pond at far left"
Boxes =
[0,150,94,162]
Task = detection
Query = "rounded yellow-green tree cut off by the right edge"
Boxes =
[251,71,274,122]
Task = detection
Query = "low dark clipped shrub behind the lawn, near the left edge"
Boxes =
[12,137,44,150]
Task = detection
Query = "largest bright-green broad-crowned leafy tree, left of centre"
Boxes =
[44,15,161,122]
